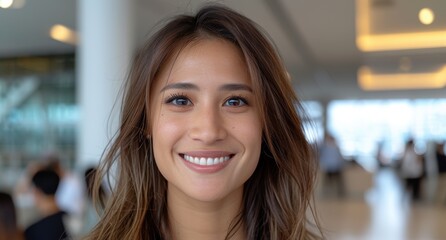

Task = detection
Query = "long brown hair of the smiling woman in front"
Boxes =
[88,4,319,240]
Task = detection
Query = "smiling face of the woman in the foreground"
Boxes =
[150,38,262,202]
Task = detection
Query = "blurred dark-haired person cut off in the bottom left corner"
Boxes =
[0,192,23,240]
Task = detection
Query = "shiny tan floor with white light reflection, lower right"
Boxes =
[317,169,446,240]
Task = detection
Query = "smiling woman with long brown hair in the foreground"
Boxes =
[88,5,319,240]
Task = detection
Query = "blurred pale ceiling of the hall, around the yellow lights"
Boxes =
[0,0,446,100]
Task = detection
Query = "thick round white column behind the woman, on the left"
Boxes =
[75,0,135,167]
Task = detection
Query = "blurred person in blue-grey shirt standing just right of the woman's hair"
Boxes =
[319,133,345,197]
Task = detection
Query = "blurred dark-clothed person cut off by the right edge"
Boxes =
[435,142,446,204]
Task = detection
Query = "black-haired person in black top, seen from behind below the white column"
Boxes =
[25,169,68,240]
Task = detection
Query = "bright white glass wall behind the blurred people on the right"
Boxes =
[327,99,446,169]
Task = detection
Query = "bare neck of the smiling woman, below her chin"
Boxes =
[167,186,246,240]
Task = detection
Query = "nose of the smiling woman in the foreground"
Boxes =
[189,106,227,144]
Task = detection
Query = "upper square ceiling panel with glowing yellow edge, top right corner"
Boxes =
[356,0,446,52]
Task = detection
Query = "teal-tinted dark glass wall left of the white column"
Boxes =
[0,55,79,178]
